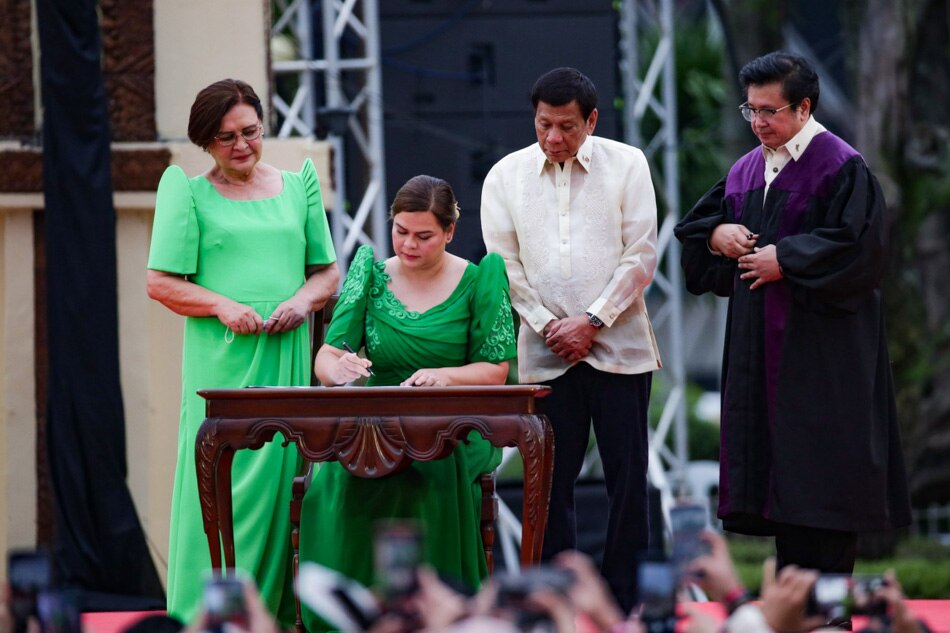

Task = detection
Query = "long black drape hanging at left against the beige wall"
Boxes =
[36,0,164,610]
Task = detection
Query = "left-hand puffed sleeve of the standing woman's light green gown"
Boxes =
[148,165,198,275]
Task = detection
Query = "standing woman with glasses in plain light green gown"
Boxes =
[147,79,339,624]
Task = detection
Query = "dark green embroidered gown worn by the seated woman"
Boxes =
[300,246,516,630]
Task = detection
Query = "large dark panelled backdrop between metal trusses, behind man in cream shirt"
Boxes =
[380,0,622,261]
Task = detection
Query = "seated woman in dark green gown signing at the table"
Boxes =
[300,176,516,629]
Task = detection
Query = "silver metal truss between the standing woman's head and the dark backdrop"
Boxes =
[272,0,389,275]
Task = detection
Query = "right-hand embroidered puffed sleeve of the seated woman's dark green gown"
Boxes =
[468,253,517,363]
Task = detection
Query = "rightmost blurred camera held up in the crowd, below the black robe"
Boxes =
[808,574,887,621]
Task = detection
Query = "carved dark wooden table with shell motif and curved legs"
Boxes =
[195,385,554,570]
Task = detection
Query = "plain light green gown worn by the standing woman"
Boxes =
[141,159,336,624]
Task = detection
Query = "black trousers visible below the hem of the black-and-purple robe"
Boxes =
[775,524,858,574]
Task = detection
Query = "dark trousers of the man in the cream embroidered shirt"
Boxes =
[537,362,653,613]
